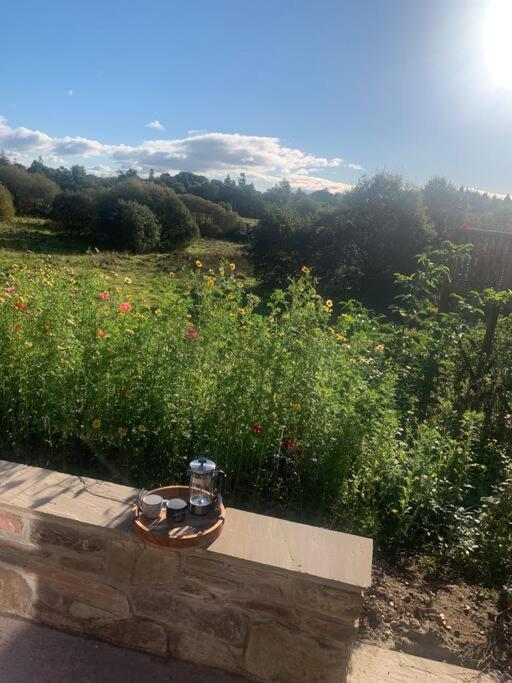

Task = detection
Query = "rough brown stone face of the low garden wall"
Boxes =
[0,466,371,683]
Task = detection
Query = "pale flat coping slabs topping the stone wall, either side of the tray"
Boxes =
[0,460,373,590]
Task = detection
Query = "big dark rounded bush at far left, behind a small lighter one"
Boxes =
[0,164,60,216]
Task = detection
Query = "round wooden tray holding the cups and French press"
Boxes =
[133,486,226,550]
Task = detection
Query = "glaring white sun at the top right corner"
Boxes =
[484,0,512,88]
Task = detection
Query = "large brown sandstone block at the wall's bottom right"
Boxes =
[245,622,350,683]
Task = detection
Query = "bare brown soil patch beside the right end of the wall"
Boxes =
[360,559,512,681]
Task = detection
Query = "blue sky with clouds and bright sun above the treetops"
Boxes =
[0,0,512,194]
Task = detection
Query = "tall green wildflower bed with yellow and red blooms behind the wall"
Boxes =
[0,251,512,585]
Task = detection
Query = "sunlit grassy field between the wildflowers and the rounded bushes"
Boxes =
[0,218,254,302]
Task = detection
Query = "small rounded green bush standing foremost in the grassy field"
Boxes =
[112,199,161,254]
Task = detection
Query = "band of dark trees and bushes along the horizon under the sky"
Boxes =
[0,155,512,308]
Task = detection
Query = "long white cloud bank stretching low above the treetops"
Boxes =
[0,117,355,191]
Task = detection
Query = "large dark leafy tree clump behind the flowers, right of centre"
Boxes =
[253,173,433,307]
